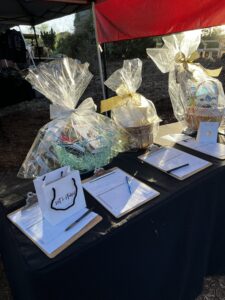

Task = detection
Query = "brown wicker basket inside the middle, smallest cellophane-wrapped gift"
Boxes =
[125,124,154,149]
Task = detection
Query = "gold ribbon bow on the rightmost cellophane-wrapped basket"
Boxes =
[175,51,222,77]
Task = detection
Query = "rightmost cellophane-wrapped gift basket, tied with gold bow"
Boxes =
[147,30,225,131]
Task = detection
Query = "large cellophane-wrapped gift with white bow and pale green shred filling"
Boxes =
[18,58,127,178]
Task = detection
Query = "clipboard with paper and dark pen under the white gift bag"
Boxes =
[7,202,102,258]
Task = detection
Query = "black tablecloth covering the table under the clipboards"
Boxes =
[0,124,225,300]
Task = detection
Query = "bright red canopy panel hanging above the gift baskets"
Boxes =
[95,0,225,43]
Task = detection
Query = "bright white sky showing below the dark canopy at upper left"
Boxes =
[15,14,74,33]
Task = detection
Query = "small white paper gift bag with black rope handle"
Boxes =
[34,167,86,225]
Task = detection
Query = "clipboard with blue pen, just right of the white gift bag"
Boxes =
[82,167,160,218]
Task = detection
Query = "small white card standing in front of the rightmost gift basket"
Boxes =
[196,122,219,144]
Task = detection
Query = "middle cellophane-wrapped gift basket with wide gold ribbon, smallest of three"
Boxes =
[105,58,161,148]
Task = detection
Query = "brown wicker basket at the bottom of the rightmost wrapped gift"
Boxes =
[185,107,224,131]
